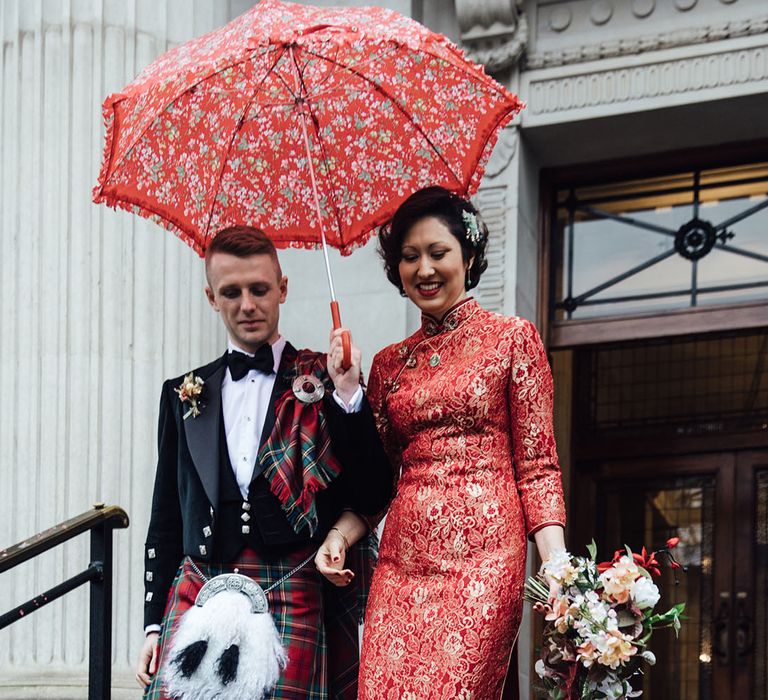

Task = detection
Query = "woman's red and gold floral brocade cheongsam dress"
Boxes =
[359,298,565,700]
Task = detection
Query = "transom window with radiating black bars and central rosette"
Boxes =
[553,163,768,321]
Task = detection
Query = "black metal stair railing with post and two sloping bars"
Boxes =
[0,503,129,700]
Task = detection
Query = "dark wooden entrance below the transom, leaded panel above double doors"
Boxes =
[553,330,768,700]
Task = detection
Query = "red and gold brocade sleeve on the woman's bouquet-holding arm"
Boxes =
[509,321,565,538]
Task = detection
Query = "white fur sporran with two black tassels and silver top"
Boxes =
[164,576,288,700]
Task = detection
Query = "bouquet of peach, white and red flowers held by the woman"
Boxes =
[525,537,685,700]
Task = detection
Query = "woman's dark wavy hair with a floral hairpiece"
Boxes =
[379,187,488,296]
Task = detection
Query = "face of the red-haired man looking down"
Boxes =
[205,253,288,352]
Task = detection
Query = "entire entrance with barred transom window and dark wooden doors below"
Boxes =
[534,144,768,700]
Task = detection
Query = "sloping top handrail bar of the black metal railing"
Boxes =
[0,503,130,574]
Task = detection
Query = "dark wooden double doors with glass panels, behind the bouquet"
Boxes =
[572,450,768,700]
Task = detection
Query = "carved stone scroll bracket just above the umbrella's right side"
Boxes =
[455,0,528,73]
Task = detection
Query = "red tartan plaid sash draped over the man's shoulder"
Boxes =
[259,347,341,536]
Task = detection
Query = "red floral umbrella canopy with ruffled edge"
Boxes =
[94,0,521,254]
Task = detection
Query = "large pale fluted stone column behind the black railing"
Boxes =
[0,0,228,698]
